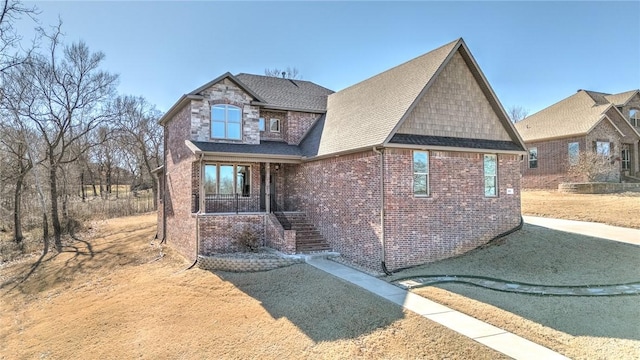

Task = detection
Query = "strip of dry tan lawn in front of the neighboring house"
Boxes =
[522,191,640,229]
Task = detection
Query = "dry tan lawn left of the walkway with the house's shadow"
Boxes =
[0,215,506,359]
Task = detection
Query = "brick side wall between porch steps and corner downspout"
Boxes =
[285,152,381,269]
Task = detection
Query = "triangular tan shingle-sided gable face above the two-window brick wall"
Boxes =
[398,53,511,141]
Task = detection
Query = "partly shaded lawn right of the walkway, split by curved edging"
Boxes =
[388,224,640,359]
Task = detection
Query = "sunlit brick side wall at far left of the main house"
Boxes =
[165,106,196,260]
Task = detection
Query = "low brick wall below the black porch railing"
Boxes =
[194,214,265,255]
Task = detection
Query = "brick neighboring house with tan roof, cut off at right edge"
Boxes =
[516,90,640,189]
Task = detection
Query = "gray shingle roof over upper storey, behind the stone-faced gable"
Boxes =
[235,74,333,112]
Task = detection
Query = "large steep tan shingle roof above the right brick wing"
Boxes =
[318,39,524,156]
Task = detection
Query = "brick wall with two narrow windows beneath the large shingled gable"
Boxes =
[385,149,520,269]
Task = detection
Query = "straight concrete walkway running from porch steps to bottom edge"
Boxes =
[307,257,568,360]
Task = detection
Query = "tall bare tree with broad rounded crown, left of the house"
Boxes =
[13,25,117,251]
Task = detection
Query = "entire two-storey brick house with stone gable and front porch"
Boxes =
[157,39,526,270]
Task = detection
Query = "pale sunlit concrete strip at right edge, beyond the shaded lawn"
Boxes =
[522,216,640,245]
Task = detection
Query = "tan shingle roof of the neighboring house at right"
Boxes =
[516,90,635,142]
